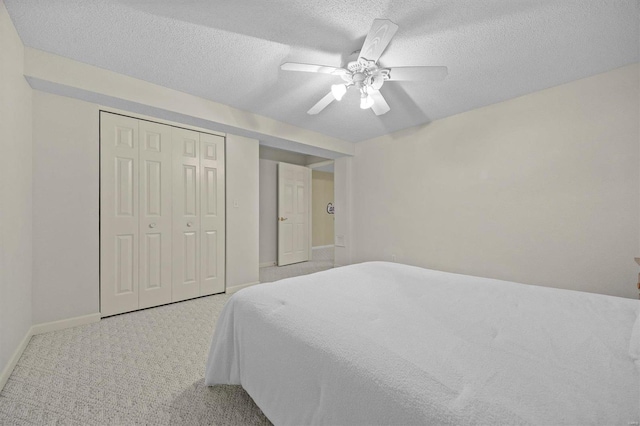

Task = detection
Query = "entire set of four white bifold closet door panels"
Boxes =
[100,112,225,316]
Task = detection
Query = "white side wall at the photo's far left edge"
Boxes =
[0,0,32,382]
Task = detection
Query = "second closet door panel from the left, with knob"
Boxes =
[138,120,172,309]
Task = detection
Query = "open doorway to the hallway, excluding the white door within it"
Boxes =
[259,146,334,282]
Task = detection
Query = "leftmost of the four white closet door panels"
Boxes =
[100,113,139,316]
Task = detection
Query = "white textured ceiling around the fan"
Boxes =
[5,0,640,141]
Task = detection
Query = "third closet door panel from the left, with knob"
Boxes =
[171,128,200,302]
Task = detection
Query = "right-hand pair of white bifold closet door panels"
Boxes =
[172,128,225,301]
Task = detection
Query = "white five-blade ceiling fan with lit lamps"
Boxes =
[280,19,448,115]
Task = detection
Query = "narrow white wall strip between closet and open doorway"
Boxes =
[226,135,260,288]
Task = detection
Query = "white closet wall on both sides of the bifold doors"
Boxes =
[33,90,258,323]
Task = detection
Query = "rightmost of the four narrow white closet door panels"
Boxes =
[200,133,225,296]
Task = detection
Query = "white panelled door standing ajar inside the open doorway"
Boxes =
[278,163,311,266]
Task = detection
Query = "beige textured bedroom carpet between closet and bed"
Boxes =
[0,295,270,425]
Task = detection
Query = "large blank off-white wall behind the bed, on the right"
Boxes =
[352,64,640,298]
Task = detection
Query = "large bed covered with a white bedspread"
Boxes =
[205,262,640,426]
